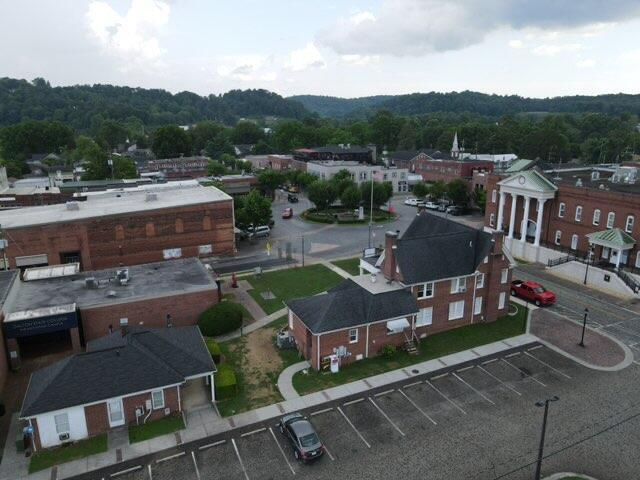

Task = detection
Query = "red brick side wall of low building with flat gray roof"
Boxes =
[80,285,218,341]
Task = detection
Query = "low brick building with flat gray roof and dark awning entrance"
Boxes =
[2,258,219,369]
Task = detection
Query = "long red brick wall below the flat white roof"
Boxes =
[7,201,234,270]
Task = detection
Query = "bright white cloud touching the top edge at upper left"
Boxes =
[86,0,170,61]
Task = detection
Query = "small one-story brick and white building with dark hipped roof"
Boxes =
[20,327,216,450]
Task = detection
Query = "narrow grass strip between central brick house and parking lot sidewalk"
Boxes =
[293,304,526,395]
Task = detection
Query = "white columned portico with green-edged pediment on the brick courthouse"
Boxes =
[496,170,558,257]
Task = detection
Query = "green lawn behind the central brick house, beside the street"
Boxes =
[246,264,343,315]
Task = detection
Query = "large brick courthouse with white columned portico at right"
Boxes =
[485,165,640,272]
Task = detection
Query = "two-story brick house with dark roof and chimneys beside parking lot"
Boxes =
[288,212,511,369]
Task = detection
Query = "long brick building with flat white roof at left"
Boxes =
[1,186,235,270]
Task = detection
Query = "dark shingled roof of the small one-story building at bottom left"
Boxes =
[21,327,215,418]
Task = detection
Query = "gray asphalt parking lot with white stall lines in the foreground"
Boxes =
[67,344,640,480]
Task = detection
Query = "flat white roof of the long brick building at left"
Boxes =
[1,186,231,229]
